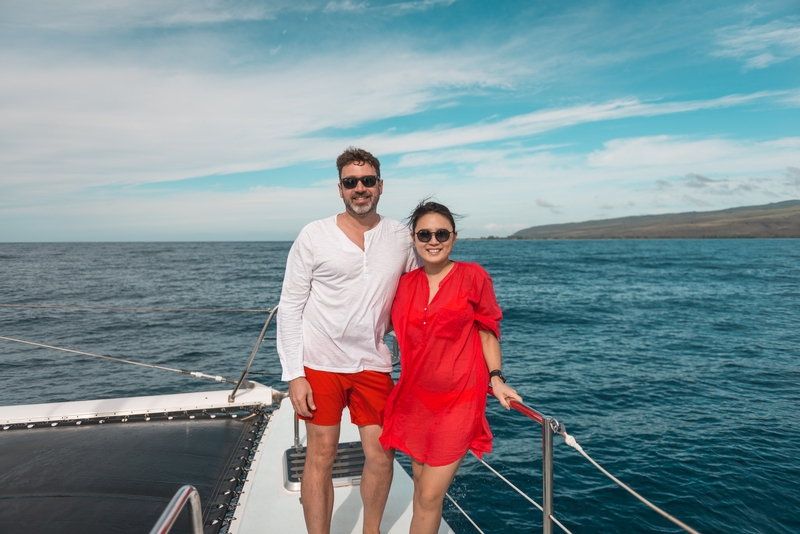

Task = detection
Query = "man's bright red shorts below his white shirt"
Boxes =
[297,367,394,426]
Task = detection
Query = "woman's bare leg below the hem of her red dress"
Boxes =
[409,457,464,534]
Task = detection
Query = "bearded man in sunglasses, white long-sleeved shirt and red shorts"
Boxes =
[278,147,418,534]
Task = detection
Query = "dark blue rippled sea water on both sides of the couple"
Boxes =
[0,244,800,534]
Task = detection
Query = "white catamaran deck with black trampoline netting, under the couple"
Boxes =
[0,388,452,534]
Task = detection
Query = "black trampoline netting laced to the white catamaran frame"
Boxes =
[0,413,266,534]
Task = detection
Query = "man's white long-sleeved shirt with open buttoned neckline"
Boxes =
[277,216,420,382]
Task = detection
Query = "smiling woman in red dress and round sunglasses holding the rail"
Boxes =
[380,201,522,534]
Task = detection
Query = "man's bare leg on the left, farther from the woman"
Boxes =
[300,422,339,534]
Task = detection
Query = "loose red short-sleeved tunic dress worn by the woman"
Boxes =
[380,262,502,466]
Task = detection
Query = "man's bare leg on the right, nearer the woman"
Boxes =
[358,425,394,534]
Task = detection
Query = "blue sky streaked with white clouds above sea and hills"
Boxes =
[0,0,800,242]
